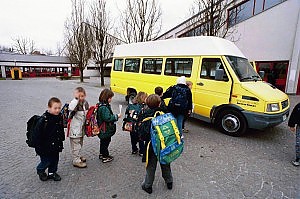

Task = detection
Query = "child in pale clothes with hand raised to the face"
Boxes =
[69,87,89,168]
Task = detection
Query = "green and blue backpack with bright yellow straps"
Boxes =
[144,111,184,164]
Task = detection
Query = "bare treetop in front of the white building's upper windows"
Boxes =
[187,0,240,38]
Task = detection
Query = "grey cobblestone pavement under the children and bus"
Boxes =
[0,78,300,199]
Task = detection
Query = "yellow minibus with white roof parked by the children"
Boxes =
[111,36,290,136]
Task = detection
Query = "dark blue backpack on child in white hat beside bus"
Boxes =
[168,85,188,112]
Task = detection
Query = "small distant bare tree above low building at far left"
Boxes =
[13,36,36,55]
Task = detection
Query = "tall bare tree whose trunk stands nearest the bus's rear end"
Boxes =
[90,0,119,86]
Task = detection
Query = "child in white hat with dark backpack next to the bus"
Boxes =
[162,76,193,135]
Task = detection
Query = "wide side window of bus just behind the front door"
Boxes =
[165,58,193,77]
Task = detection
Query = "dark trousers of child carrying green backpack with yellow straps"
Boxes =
[143,146,173,188]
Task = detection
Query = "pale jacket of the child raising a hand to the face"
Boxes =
[69,98,89,138]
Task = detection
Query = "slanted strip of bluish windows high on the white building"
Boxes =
[227,0,286,27]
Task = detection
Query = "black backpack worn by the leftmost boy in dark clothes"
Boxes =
[26,114,47,148]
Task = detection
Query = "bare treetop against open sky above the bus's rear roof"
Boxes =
[119,0,161,43]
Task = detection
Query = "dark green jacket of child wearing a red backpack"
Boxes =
[97,103,119,139]
